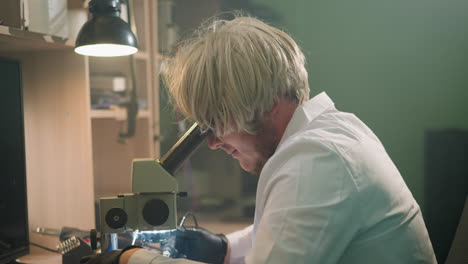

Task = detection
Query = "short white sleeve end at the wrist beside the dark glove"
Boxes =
[226,225,253,264]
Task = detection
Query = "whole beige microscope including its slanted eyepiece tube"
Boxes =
[96,123,208,251]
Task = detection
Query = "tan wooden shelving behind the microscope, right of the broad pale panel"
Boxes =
[89,0,159,198]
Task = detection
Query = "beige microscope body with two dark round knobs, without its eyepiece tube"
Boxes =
[99,159,178,250]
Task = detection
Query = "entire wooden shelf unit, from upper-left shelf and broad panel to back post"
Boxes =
[0,0,159,243]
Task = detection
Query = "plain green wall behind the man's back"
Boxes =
[252,0,468,204]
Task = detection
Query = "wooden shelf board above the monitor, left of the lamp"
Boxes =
[0,25,74,51]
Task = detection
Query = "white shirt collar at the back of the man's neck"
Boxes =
[278,92,335,147]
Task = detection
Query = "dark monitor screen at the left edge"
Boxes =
[0,58,29,264]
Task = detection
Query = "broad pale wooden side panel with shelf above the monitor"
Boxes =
[0,26,94,242]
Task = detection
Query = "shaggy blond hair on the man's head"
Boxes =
[162,17,309,136]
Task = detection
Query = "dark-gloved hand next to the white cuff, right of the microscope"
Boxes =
[163,227,228,264]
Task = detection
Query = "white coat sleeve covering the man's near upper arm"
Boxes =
[246,145,360,264]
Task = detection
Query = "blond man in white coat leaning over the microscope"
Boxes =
[83,17,436,264]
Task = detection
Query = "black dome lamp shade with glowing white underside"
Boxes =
[75,0,138,57]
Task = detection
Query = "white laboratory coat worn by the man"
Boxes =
[127,93,436,264]
